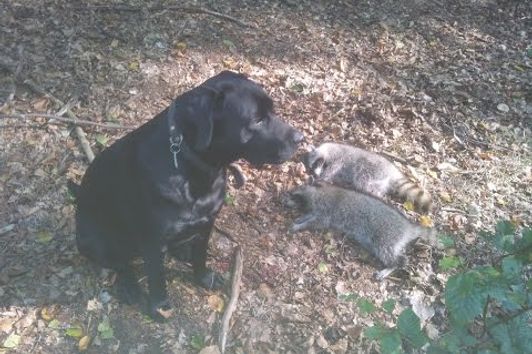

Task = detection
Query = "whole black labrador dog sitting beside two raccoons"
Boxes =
[71,71,303,319]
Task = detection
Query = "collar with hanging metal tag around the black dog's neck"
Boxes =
[166,101,221,178]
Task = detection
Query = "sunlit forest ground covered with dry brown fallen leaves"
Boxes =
[0,0,532,353]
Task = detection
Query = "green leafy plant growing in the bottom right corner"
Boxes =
[364,222,532,354]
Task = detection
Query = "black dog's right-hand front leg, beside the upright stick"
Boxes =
[192,222,224,290]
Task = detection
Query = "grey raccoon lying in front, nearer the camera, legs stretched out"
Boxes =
[290,183,437,279]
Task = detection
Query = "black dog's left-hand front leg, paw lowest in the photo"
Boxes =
[143,242,171,321]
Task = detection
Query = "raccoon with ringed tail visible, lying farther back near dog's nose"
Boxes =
[304,143,432,212]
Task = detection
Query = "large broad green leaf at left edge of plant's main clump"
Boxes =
[445,271,487,326]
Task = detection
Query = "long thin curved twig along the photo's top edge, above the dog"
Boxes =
[74,5,257,28]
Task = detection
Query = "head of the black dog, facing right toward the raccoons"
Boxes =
[175,71,303,165]
